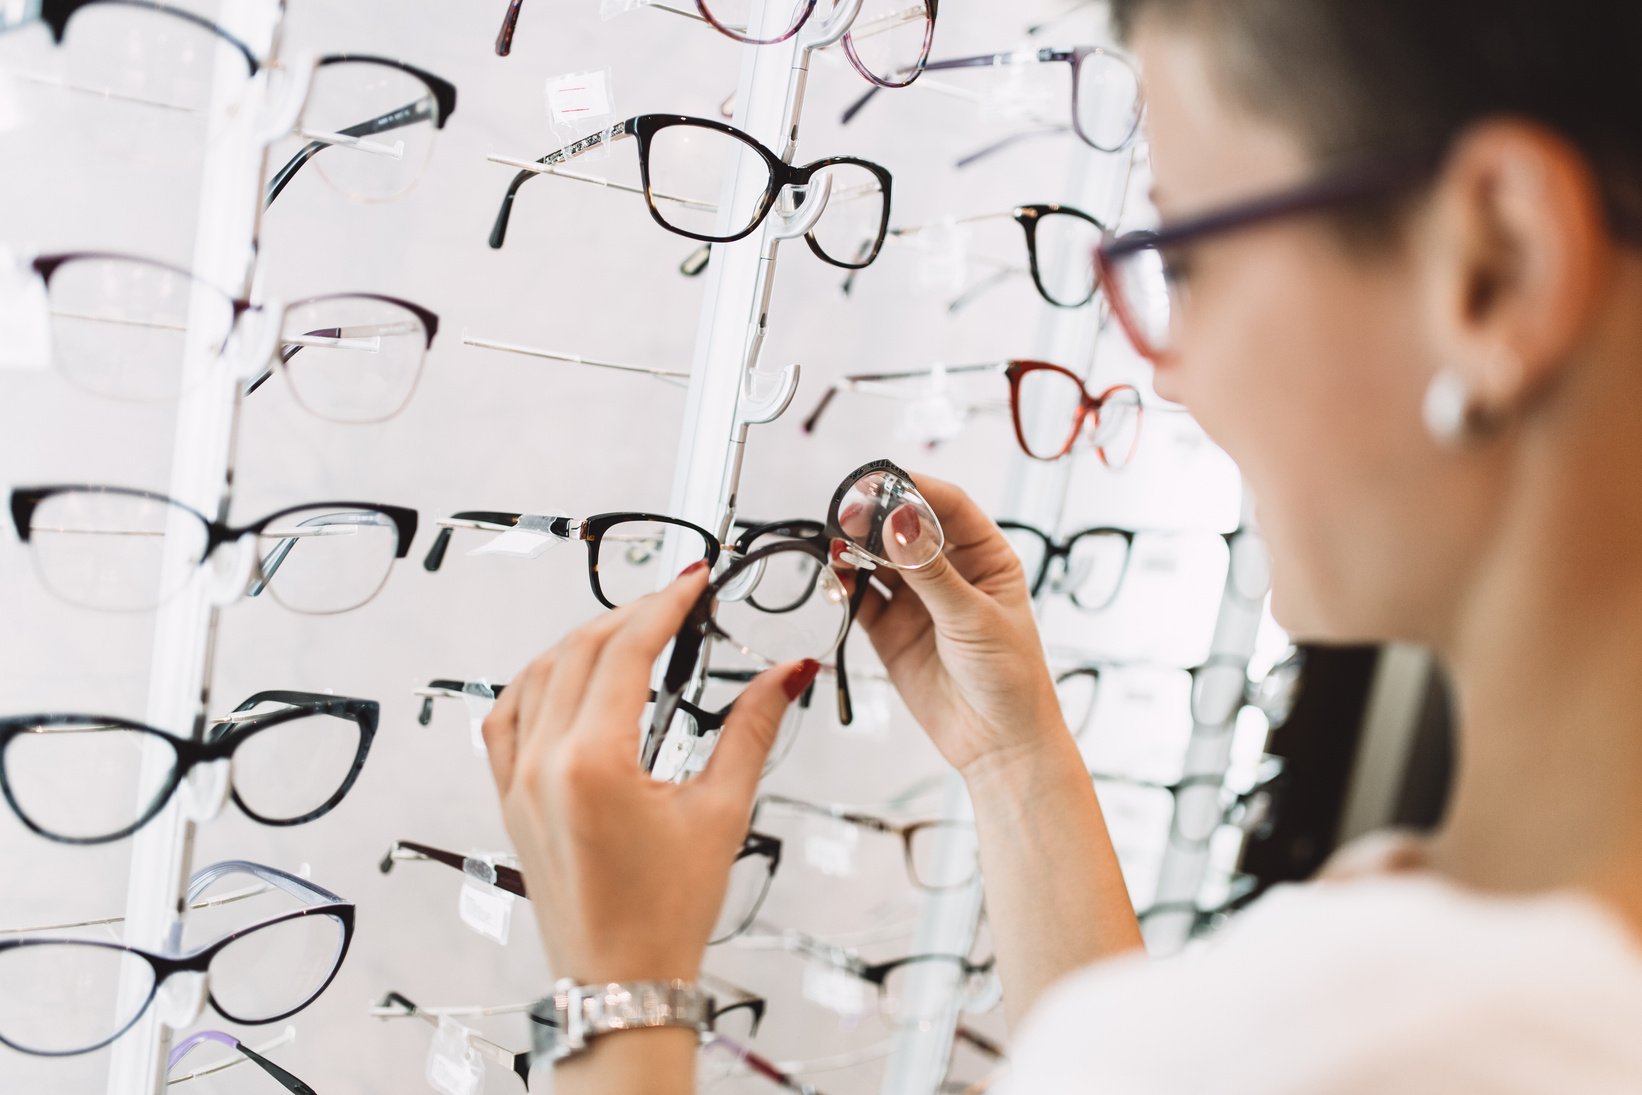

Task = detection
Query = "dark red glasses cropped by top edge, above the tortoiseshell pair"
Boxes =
[496,0,939,87]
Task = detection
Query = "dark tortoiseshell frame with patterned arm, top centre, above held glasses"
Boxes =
[491,113,893,269]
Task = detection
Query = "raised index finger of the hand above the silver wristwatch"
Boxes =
[576,566,708,763]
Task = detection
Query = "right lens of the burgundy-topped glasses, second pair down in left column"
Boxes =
[279,296,427,422]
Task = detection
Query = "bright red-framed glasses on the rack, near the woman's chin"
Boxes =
[803,361,1146,470]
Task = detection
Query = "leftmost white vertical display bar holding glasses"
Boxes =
[107,0,284,1095]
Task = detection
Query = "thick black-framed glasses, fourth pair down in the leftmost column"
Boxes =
[0,691,381,844]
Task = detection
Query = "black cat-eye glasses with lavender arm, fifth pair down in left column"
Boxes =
[0,860,353,1057]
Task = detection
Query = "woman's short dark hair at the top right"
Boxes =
[1112,0,1642,220]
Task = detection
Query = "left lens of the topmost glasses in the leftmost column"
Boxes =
[62,3,251,155]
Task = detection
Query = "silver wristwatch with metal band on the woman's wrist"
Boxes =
[530,978,713,1064]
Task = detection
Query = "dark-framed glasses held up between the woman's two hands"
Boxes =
[640,460,946,772]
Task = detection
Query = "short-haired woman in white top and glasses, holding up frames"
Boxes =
[484,0,1642,1095]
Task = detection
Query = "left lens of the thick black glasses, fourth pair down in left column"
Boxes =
[0,719,177,841]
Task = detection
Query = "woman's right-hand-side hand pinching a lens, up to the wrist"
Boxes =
[855,478,1069,777]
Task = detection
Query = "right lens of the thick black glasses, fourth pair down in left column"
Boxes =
[223,701,361,822]
